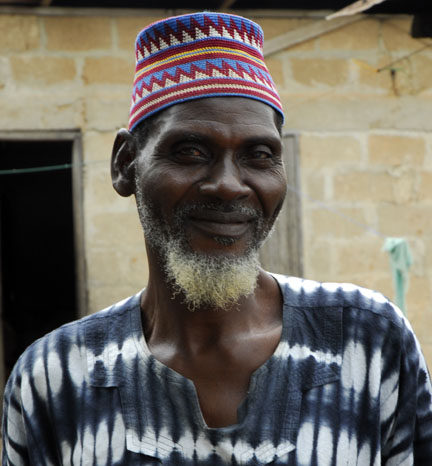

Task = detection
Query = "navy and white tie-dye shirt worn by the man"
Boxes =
[3,276,432,466]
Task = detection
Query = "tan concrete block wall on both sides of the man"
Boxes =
[0,9,432,365]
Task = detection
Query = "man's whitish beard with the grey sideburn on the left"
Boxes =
[136,183,267,311]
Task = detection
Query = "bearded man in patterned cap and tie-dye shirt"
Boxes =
[3,13,432,466]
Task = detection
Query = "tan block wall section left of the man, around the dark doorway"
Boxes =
[0,10,164,312]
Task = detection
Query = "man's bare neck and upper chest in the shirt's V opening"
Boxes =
[141,262,283,427]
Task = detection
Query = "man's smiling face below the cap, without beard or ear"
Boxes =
[136,97,286,256]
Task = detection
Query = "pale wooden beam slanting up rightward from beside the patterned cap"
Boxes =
[264,15,364,57]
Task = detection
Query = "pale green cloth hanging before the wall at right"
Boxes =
[383,238,413,314]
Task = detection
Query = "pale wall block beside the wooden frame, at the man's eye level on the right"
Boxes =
[300,134,362,171]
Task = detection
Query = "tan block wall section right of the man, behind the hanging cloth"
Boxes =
[261,17,432,365]
